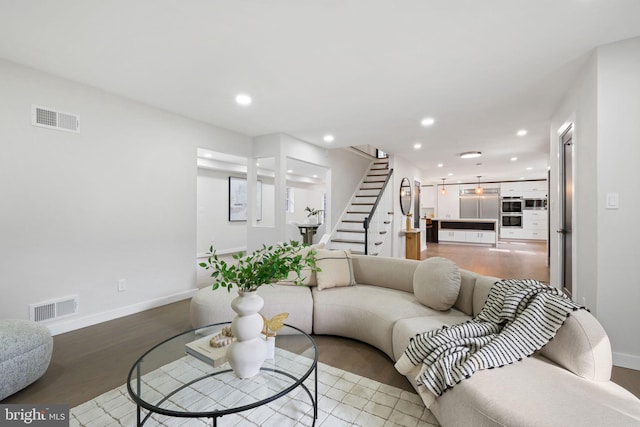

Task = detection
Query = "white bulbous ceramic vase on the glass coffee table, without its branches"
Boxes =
[227,291,267,378]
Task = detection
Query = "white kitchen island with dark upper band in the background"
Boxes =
[438,219,498,246]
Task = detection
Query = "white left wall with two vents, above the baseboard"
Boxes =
[0,61,251,333]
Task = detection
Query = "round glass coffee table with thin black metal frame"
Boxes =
[127,322,318,427]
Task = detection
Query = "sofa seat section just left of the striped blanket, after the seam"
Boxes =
[393,309,471,360]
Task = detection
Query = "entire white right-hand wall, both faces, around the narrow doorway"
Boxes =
[550,38,640,369]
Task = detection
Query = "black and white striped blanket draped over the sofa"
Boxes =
[396,280,582,402]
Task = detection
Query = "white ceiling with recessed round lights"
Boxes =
[0,0,640,186]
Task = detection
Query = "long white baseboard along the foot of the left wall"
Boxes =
[45,289,198,335]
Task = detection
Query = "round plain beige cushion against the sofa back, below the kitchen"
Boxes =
[413,257,460,311]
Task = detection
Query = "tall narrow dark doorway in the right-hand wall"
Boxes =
[558,125,574,298]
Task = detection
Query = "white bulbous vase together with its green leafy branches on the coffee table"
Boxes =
[200,241,318,378]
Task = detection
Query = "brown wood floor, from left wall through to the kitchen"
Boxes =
[2,242,640,407]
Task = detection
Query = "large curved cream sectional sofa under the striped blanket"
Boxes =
[191,250,640,427]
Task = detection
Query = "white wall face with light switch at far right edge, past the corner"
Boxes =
[592,38,640,369]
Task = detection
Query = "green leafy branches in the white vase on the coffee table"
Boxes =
[199,240,320,292]
